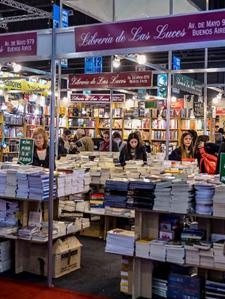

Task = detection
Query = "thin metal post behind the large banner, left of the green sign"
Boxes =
[165,0,173,160]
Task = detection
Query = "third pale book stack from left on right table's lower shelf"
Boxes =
[166,244,185,265]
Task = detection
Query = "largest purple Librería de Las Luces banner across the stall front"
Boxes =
[75,10,225,52]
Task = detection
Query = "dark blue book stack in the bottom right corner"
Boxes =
[205,280,225,299]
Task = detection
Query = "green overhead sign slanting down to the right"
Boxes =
[173,74,202,96]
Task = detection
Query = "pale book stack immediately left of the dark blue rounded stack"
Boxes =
[170,180,194,214]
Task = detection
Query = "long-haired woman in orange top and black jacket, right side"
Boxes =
[169,132,194,161]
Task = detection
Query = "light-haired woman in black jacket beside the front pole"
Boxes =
[32,127,49,168]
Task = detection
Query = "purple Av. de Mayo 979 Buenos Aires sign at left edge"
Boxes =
[0,32,37,57]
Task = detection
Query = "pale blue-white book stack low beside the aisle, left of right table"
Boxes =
[105,228,135,256]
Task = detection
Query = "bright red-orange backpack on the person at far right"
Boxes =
[200,147,218,174]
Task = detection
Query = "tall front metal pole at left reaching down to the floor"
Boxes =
[48,27,56,287]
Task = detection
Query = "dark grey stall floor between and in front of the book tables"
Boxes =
[0,237,130,299]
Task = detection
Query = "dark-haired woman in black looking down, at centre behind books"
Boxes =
[119,133,147,166]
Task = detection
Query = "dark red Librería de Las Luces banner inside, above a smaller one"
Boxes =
[69,72,152,89]
